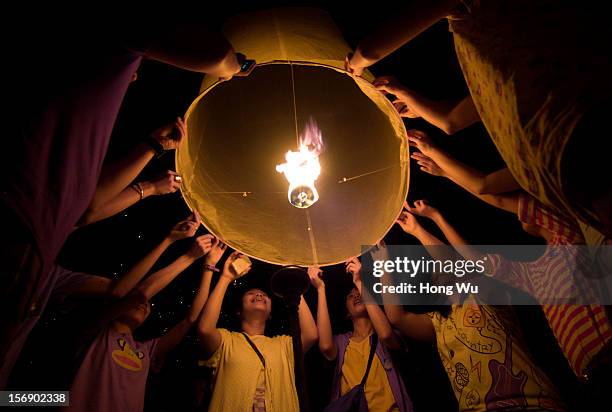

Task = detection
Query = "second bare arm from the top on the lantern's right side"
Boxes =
[374,76,480,135]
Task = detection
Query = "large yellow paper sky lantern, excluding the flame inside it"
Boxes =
[176,8,409,266]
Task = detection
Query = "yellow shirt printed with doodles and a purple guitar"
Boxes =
[430,297,564,411]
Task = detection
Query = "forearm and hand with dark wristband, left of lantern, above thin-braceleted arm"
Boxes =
[86,118,187,214]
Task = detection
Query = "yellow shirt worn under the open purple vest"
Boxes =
[340,337,399,412]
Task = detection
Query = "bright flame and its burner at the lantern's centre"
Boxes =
[276,118,323,209]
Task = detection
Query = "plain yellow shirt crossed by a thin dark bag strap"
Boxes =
[200,329,299,412]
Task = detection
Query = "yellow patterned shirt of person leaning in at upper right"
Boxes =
[449,0,612,230]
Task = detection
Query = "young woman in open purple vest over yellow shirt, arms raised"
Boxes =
[308,258,412,412]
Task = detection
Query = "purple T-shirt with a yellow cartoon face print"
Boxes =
[68,328,158,412]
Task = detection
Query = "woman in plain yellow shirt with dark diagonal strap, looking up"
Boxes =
[198,252,317,412]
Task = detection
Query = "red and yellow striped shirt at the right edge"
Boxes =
[489,195,612,376]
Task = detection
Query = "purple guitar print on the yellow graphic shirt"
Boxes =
[485,333,527,411]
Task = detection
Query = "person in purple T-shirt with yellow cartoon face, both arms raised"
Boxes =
[67,235,225,411]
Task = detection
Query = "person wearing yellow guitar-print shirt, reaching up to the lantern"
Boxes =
[382,211,564,411]
